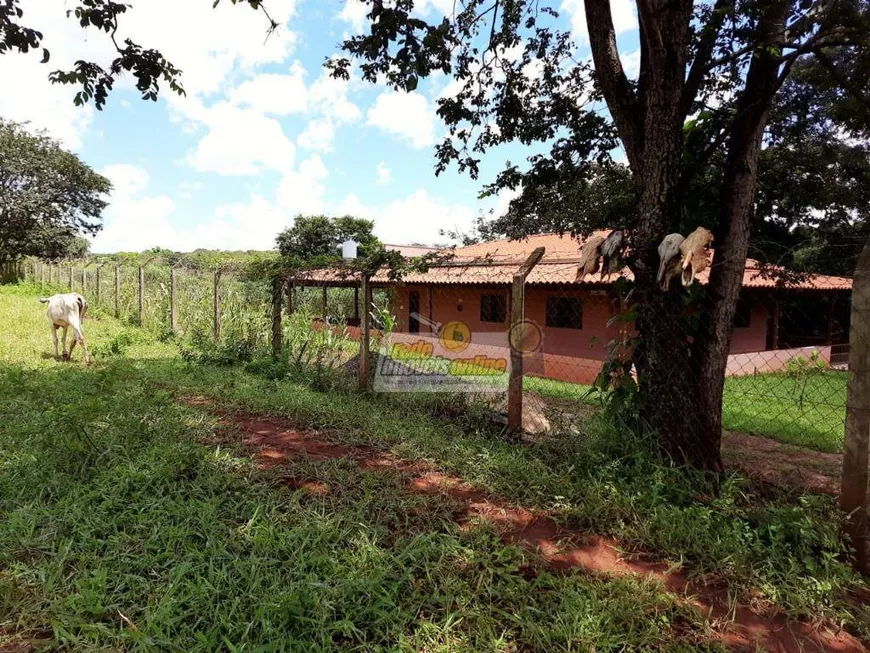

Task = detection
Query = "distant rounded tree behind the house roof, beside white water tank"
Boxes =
[276,215,383,261]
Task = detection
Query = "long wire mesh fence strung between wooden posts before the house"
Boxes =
[15,252,851,451]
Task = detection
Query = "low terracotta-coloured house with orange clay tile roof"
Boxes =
[291,232,852,383]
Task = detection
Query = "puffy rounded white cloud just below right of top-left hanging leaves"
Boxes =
[187,102,295,175]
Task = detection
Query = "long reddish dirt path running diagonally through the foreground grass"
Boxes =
[183,397,868,653]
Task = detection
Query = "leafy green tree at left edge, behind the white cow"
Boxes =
[0,119,111,261]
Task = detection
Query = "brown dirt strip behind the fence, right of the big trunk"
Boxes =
[722,431,843,496]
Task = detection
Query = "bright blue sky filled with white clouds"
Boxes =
[0,0,637,252]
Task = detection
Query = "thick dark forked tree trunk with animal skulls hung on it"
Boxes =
[585,0,787,471]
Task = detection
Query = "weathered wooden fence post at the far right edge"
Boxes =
[840,240,870,574]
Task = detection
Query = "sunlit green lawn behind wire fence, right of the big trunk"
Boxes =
[722,370,848,451]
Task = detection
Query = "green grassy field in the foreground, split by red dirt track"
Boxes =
[0,287,870,651]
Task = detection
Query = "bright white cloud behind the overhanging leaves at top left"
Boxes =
[0,0,295,149]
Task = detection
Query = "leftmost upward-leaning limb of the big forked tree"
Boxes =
[585,0,642,170]
